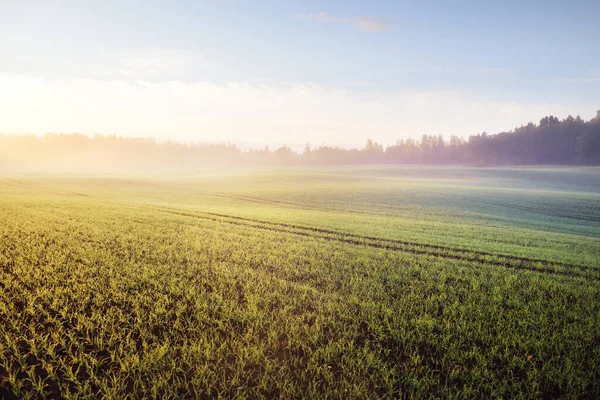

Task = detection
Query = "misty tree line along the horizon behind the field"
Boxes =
[0,110,600,171]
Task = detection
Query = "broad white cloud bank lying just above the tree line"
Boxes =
[0,75,596,145]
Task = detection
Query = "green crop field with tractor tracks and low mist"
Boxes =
[0,166,600,399]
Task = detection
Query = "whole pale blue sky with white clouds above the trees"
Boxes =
[0,0,600,147]
